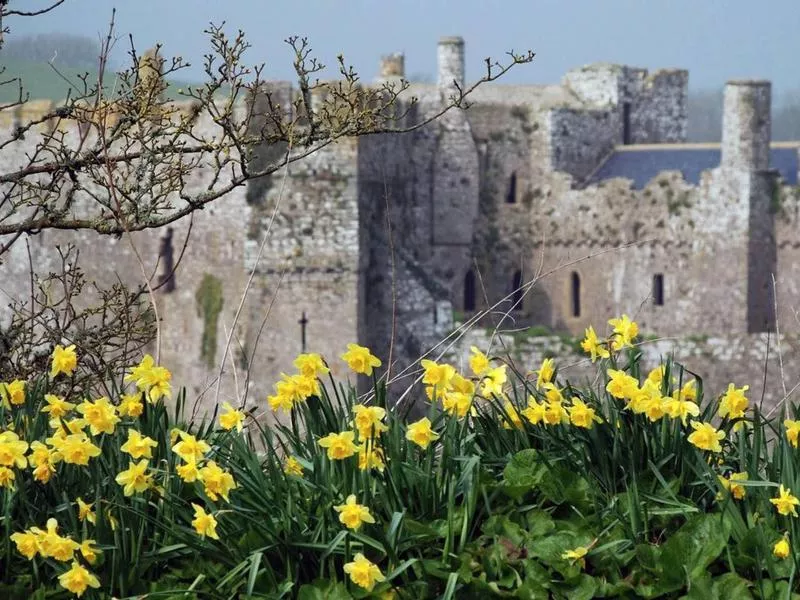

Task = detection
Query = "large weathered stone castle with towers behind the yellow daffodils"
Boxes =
[0,37,800,412]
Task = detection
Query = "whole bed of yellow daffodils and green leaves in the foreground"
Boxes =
[0,317,800,599]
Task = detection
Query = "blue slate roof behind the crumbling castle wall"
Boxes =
[589,144,798,190]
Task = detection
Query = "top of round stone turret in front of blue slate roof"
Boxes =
[721,80,772,171]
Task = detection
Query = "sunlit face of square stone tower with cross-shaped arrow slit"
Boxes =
[243,139,360,399]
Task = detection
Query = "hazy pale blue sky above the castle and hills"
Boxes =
[10,0,800,96]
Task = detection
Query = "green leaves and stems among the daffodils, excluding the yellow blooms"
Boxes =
[7,344,800,600]
